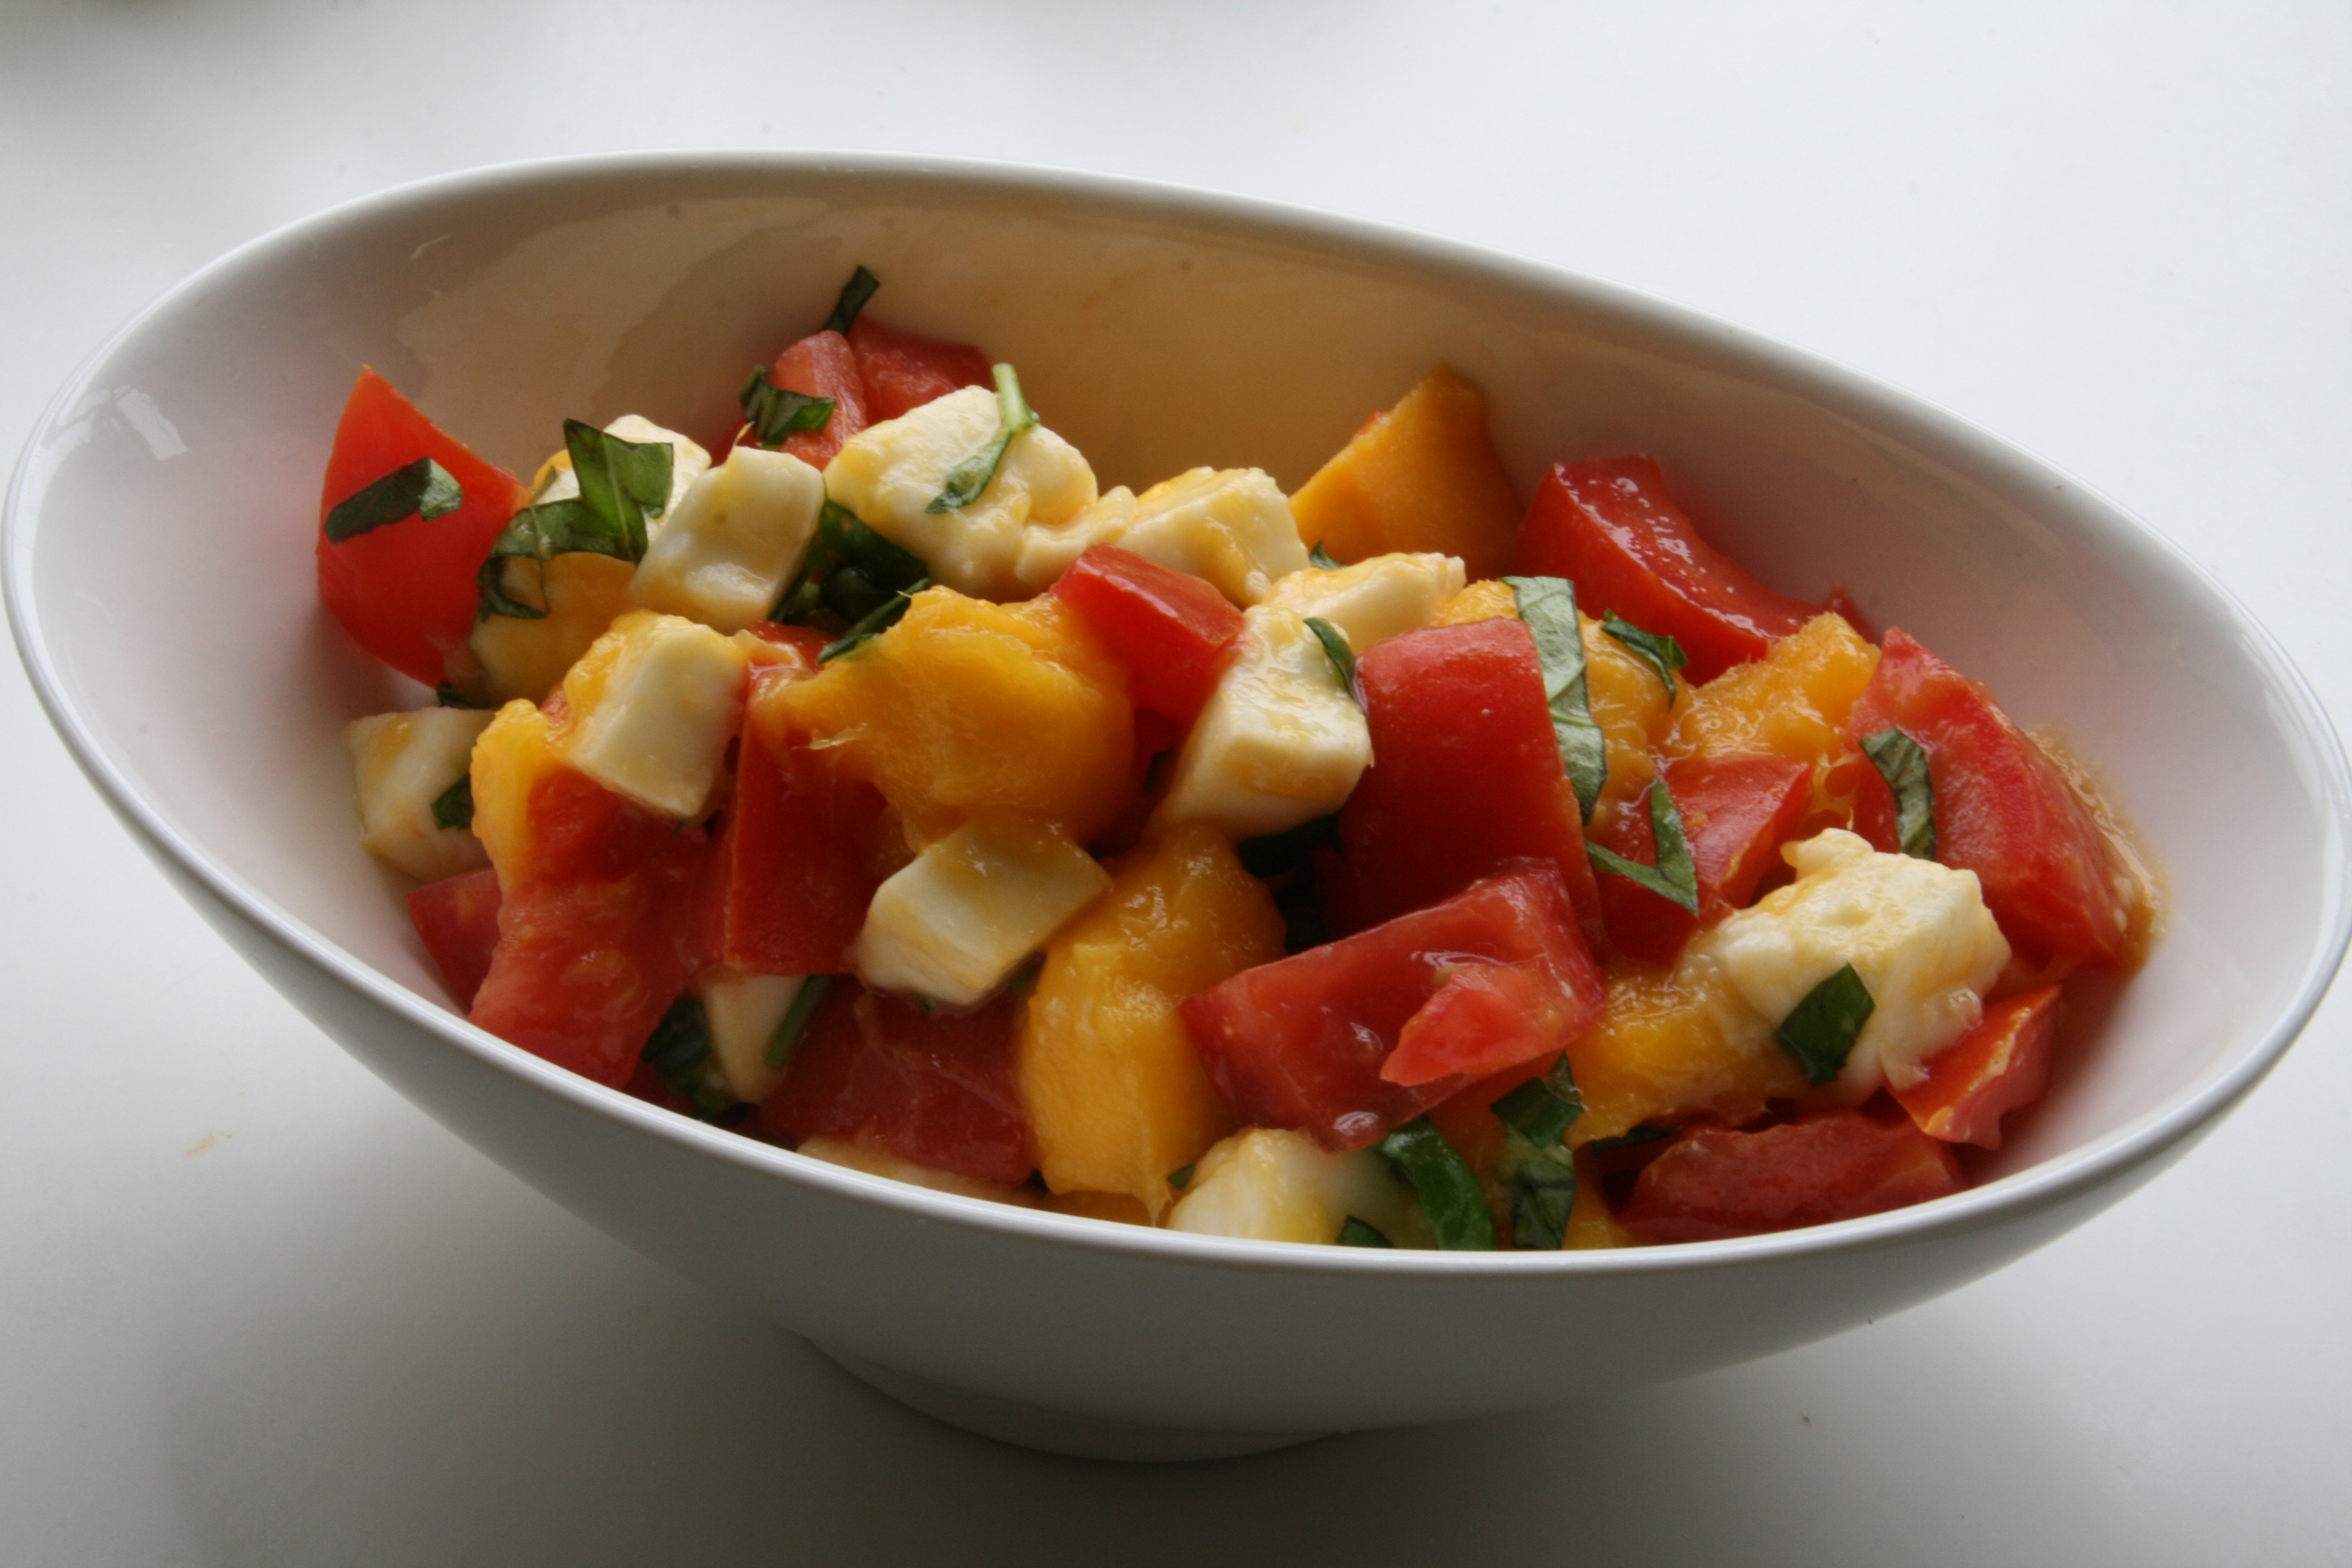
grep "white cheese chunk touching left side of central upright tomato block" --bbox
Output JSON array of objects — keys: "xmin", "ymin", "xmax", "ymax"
[{"xmin": 1157, "ymin": 604, "xmax": 1371, "ymax": 839}]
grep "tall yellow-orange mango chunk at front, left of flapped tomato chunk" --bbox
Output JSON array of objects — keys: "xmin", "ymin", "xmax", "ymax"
[{"xmin": 1019, "ymin": 823, "xmax": 1282, "ymax": 1220}]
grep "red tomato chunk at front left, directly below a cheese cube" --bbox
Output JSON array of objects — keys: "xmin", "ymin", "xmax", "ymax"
[{"xmin": 471, "ymin": 769, "xmax": 713, "ymax": 1086}]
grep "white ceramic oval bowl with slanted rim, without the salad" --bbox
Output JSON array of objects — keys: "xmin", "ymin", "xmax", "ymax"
[{"xmin": 7, "ymin": 153, "xmax": 2347, "ymax": 1457}]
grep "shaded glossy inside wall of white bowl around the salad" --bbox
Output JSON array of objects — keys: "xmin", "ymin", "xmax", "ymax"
[{"xmin": 10, "ymin": 157, "xmax": 2345, "ymax": 1213}]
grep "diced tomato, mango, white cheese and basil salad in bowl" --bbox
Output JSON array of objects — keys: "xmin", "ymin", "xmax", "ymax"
[{"xmin": 318, "ymin": 268, "xmax": 2152, "ymax": 1248}]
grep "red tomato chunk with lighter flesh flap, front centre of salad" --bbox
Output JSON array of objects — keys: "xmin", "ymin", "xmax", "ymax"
[{"xmin": 1178, "ymin": 863, "xmax": 1607, "ymax": 1149}]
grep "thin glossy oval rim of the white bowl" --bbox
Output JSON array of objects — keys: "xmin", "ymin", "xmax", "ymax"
[{"xmin": 18, "ymin": 148, "xmax": 2352, "ymax": 1279}]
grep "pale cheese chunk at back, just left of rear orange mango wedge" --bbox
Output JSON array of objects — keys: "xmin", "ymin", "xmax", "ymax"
[{"xmin": 1019, "ymin": 468, "xmax": 1308, "ymax": 609}]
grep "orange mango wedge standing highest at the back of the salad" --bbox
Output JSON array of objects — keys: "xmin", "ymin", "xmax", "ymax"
[{"xmin": 1292, "ymin": 364, "xmax": 1526, "ymax": 578}]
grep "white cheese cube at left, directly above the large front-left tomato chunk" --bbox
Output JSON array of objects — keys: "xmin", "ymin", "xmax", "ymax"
[{"xmin": 564, "ymin": 609, "xmax": 748, "ymax": 820}]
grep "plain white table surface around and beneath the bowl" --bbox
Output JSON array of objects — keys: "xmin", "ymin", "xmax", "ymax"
[{"xmin": 0, "ymin": 0, "xmax": 2352, "ymax": 1566}]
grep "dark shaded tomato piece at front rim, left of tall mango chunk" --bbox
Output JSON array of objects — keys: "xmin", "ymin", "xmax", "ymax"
[{"xmin": 760, "ymin": 976, "xmax": 1037, "ymax": 1187}]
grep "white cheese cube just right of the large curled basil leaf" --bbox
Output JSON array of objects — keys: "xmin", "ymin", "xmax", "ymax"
[{"xmin": 628, "ymin": 446, "xmax": 826, "ymax": 632}]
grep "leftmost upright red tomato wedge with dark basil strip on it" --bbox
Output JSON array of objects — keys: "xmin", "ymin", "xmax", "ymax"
[{"xmin": 318, "ymin": 369, "xmax": 529, "ymax": 687}]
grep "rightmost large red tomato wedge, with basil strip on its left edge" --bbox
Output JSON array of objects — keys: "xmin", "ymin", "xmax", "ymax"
[{"xmin": 1851, "ymin": 630, "xmax": 2135, "ymax": 964}]
